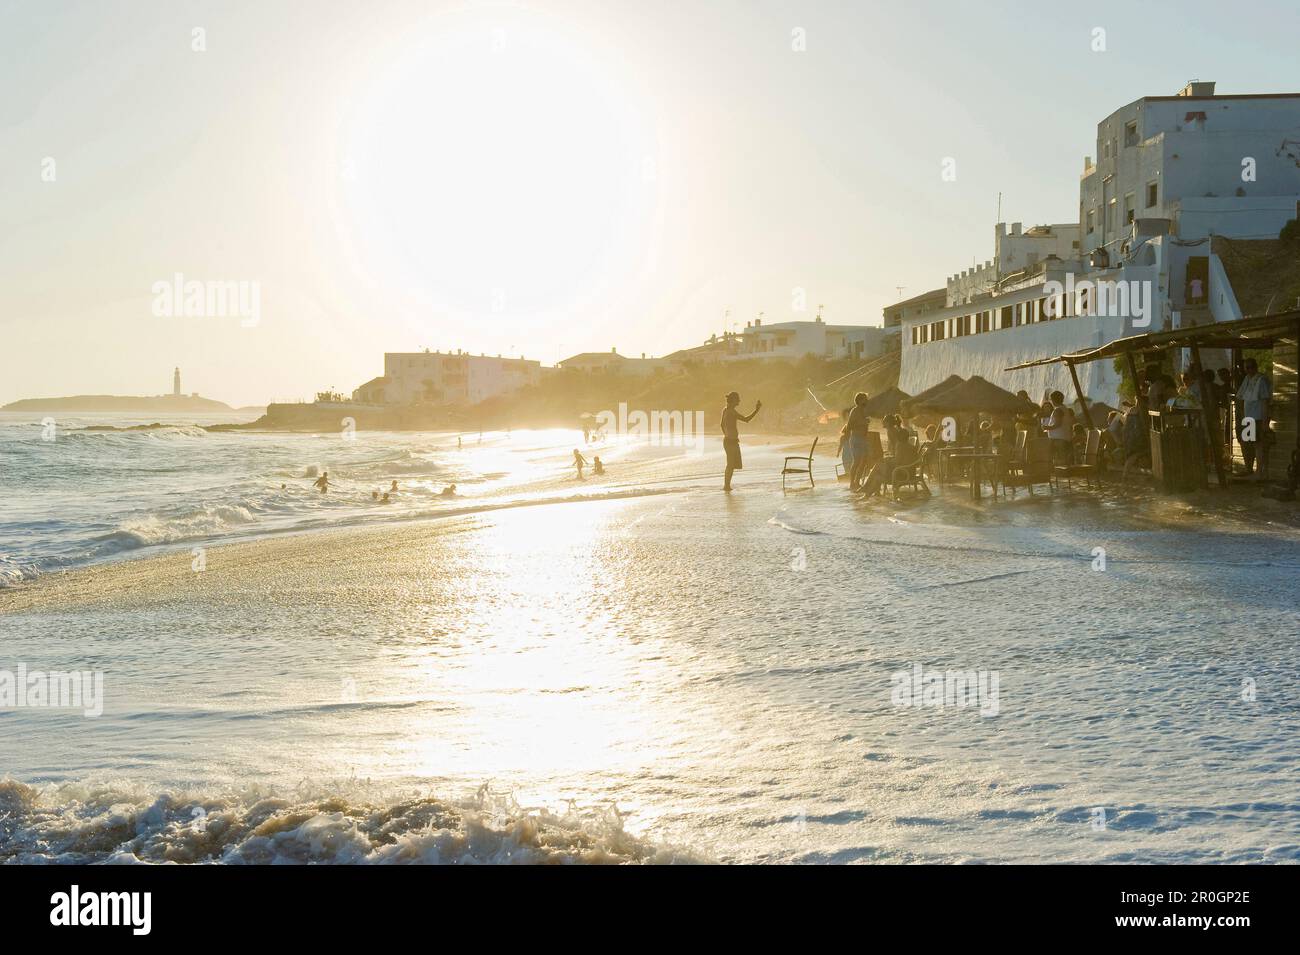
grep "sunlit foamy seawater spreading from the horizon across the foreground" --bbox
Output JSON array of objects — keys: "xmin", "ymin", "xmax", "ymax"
[{"xmin": 0, "ymin": 414, "xmax": 1300, "ymax": 864}]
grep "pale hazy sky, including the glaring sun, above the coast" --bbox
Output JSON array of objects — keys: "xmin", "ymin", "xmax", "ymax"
[{"xmin": 0, "ymin": 0, "xmax": 1300, "ymax": 405}]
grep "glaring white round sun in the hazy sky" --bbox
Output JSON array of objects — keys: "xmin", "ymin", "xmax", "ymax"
[{"xmin": 343, "ymin": 9, "xmax": 658, "ymax": 333}]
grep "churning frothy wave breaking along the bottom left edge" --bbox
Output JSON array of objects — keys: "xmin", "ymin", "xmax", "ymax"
[{"xmin": 0, "ymin": 780, "xmax": 706, "ymax": 865}]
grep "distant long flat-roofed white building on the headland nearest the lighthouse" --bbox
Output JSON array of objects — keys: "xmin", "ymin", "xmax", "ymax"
[{"xmin": 352, "ymin": 350, "xmax": 541, "ymax": 405}]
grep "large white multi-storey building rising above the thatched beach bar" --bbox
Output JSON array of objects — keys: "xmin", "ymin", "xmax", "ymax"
[{"xmin": 898, "ymin": 83, "xmax": 1300, "ymax": 404}]
